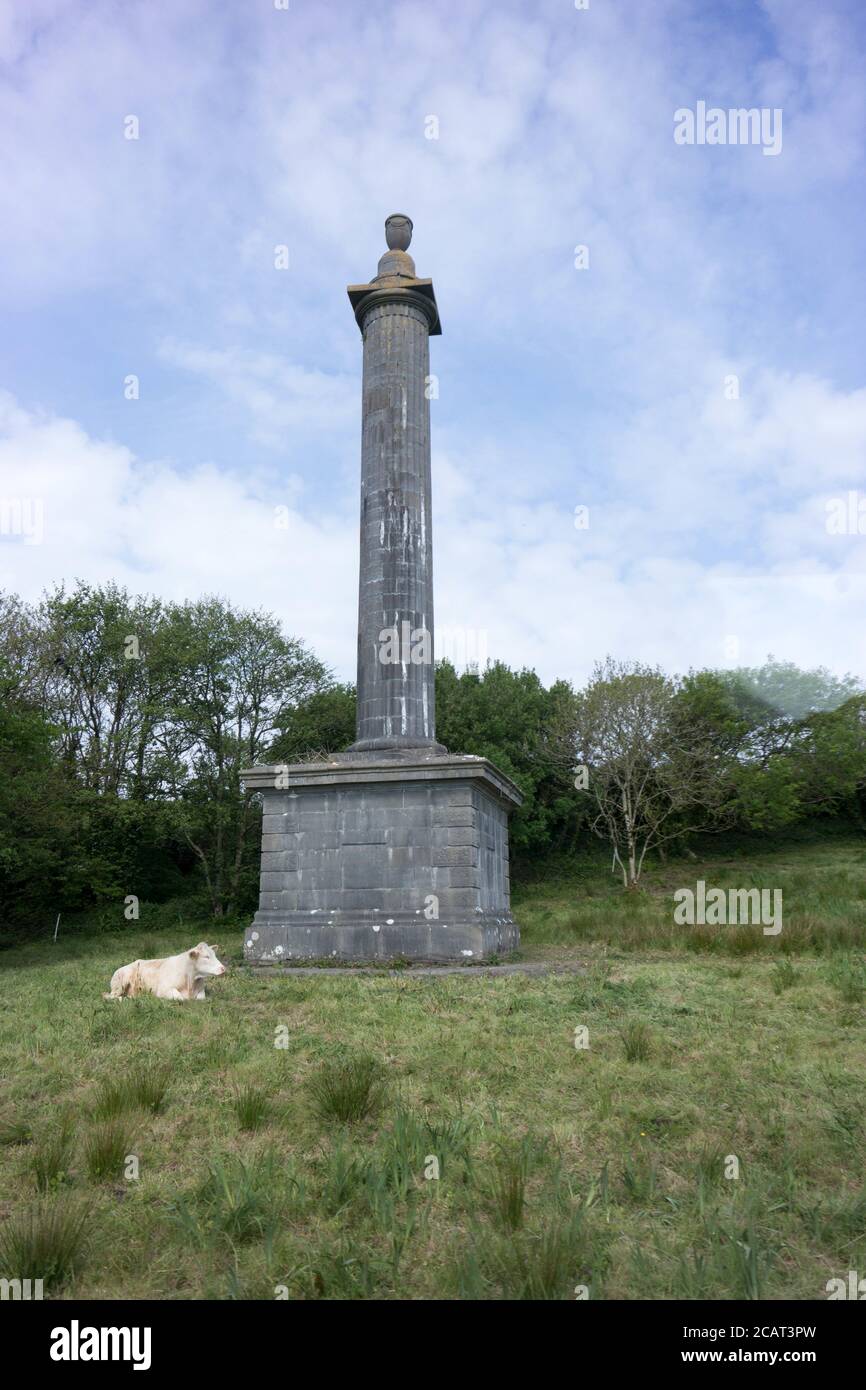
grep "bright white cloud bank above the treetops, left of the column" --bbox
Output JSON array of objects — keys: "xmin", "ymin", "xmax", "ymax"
[{"xmin": 0, "ymin": 398, "xmax": 357, "ymax": 669}]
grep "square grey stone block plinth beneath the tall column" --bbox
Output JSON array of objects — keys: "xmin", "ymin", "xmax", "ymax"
[{"xmin": 243, "ymin": 755, "xmax": 523, "ymax": 965}]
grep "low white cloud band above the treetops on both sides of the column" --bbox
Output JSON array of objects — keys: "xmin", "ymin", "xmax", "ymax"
[{"xmin": 0, "ymin": 382, "xmax": 866, "ymax": 692}]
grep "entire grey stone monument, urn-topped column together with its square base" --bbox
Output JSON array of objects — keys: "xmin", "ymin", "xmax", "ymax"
[{"xmin": 242, "ymin": 215, "xmax": 523, "ymax": 965}]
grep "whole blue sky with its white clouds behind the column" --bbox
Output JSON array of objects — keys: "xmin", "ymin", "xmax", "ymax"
[{"xmin": 0, "ymin": 0, "xmax": 866, "ymax": 681}]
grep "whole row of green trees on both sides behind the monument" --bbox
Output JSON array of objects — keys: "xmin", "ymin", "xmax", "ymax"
[{"xmin": 0, "ymin": 582, "xmax": 866, "ymax": 927}]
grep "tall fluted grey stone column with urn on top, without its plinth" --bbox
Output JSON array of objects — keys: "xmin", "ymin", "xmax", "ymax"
[{"xmin": 349, "ymin": 214, "xmax": 445, "ymax": 753}]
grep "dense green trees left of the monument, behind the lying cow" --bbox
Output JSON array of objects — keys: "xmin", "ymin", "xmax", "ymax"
[{"xmin": 0, "ymin": 584, "xmax": 329, "ymax": 919}]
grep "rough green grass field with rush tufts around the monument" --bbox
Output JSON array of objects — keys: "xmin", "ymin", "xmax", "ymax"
[{"xmin": 0, "ymin": 837, "xmax": 866, "ymax": 1298}]
